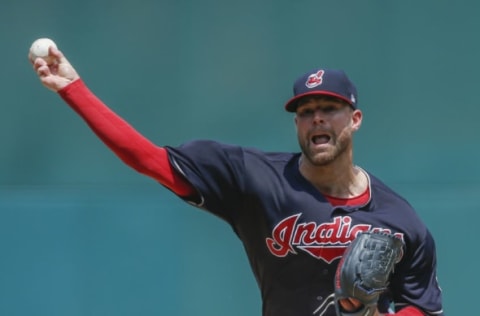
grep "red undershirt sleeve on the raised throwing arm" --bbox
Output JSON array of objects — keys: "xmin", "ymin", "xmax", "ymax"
[{"xmin": 58, "ymin": 79, "xmax": 195, "ymax": 197}]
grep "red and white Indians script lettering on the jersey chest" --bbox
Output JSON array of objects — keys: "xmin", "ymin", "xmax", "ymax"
[{"xmin": 265, "ymin": 213, "xmax": 403, "ymax": 263}]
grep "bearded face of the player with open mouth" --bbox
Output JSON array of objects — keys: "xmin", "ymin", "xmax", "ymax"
[{"xmin": 295, "ymin": 97, "xmax": 362, "ymax": 166}]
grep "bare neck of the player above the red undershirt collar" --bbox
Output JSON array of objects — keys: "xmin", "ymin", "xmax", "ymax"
[{"xmin": 299, "ymin": 155, "xmax": 368, "ymax": 198}]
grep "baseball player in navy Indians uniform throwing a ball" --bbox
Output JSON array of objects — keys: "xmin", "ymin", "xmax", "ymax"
[{"xmin": 31, "ymin": 47, "xmax": 444, "ymax": 316}]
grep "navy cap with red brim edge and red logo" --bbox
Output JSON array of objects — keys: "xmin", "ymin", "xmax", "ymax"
[{"xmin": 285, "ymin": 69, "xmax": 357, "ymax": 112}]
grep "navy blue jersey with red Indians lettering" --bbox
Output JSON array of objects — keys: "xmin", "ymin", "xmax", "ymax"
[{"xmin": 167, "ymin": 141, "xmax": 443, "ymax": 316}]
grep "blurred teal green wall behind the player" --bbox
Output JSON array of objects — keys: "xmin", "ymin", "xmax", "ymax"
[{"xmin": 0, "ymin": 0, "xmax": 480, "ymax": 316}]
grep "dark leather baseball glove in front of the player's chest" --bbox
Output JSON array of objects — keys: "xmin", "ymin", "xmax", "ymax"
[{"xmin": 334, "ymin": 232, "xmax": 403, "ymax": 316}]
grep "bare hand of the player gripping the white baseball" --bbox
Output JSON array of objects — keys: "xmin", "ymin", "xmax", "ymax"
[{"xmin": 28, "ymin": 38, "xmax": 80, "ymax": 92}]
